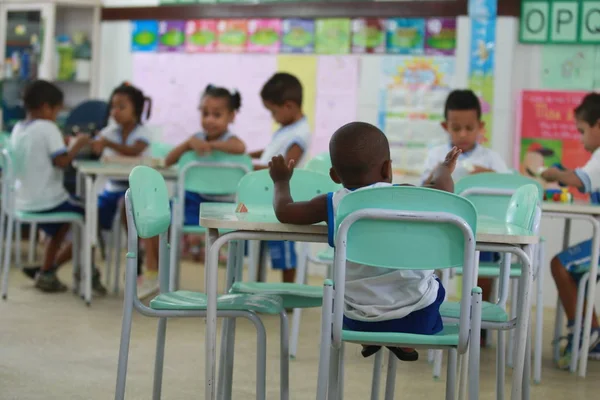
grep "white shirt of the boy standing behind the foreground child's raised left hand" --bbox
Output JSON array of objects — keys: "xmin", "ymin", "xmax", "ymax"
[{"xmin": 260, "ymin": 117, "xmax": 310, "ymax": 167}]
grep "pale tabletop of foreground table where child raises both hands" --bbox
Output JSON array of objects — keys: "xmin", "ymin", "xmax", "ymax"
[{"xmin": 200, "ymin": 203, "xmax": 539, "ymax": 245}]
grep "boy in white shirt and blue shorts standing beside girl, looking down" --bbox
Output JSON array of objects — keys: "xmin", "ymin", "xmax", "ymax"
[{"xmin": 250, "ymin": 72, "xmax": 310, "ymax": 283}]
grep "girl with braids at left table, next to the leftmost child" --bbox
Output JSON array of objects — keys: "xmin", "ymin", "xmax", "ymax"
[{"xmin": 92, "ymin": 83, "xmax": 158, "ymax": 294}]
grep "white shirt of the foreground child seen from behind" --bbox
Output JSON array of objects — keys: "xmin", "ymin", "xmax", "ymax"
[{"xmin": 327, "ymin": 183, "xmax": 440, "ymax": 322}]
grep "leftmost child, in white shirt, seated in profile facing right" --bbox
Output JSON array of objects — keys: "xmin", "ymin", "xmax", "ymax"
[{"xmin": 11, "ymin": 81, "xmax": 106, "ymax": 294}]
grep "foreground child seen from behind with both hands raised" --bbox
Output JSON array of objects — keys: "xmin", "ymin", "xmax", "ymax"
[{"xmin": 269, "ymin": 122, "xmax": 460, "ymax": 361}]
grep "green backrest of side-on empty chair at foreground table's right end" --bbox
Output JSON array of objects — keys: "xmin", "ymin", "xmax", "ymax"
[{"xmin": 506, "ymin": 185, "xmax": 542, "ymax": 233}]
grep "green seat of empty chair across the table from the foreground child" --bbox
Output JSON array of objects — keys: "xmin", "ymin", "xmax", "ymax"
[{"xmin": 230, "ymin": 282, "xmax": 323, "ymax": 308}]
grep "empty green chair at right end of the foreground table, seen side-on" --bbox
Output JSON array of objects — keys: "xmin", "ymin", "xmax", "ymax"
[{"xmin": 436, "ymin": 184, "xmax": 543, "ymax": 399}]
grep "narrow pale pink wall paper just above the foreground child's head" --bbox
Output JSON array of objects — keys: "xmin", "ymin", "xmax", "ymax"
[{"xmin": 310, "ymin": 56, "xmax": 359, "ymax": 155}]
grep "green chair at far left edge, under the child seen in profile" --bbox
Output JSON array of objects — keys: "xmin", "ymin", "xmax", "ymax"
[{"xmin": 0, "ymin": 147, "xmax": 92, "ymax": 305}]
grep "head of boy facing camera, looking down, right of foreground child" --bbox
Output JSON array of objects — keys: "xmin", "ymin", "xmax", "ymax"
[{"xmin": 442, "ymin": 90, "xmax": 484, "ymax": 153}]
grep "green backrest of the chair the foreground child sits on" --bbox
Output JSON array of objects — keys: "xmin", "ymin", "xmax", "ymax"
[{"xmin": 336, "ymin": 186, "xmax": 477, "ymax": 270}]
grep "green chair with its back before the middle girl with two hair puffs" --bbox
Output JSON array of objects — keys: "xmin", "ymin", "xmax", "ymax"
[{"xmin": 170, "ymin": 151, "xmax": 252, "ymax": 290}]
